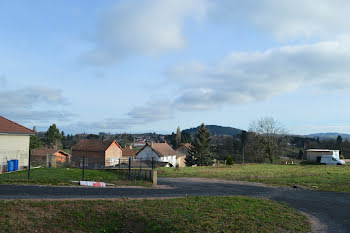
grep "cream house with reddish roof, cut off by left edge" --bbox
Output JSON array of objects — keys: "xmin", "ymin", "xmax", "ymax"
[{"xmin": 0, "ymin": 116, "xmax": 35, "ymax": 172}]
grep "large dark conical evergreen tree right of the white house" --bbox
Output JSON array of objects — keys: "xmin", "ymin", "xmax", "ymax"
[{"xmin": 186, "ymin": 123, "xmax": 214, "ymax": 166}]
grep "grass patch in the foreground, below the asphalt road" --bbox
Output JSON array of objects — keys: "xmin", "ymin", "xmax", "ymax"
[{"xmin": 0, "ymin": 197, "xmax": 310, "ymax": 232}]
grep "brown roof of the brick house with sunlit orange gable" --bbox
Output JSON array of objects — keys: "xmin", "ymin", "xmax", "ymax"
[{"xmin": 72, "ymin": 139, "xmax": 123, "ymax": 151}]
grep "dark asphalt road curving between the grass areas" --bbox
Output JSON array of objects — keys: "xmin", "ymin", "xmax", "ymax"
[{"xmin": 0, "ymin": 178, "xmax": 350, "ymax": 232}]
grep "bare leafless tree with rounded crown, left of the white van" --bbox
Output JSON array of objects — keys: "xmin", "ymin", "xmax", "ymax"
[{"xmin": 249, "ymin": 117, "xmax": 287, "ymax": 163}]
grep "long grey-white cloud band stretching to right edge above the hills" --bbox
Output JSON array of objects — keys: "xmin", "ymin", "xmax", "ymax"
[{"xmin": 167, "ymin": 39, "xmax": 350, "ymax": 110}]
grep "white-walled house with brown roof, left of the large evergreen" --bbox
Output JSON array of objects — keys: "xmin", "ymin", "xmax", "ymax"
[{"xmin": 136, "ymin": 142, "xmax": 176, "ymax": 167}]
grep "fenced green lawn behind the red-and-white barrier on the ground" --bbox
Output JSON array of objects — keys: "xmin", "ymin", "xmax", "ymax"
[{"xmin": 0, "ymin": 168, "xmax": 151, "ymax": 186}]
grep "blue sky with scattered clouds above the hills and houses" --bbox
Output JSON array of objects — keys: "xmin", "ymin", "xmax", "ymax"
[{"xmin": 0, "ymin": 0, "xmax": 350, "ymax": 134}]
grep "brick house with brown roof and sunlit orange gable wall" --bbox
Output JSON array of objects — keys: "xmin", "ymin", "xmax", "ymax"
[{"xmin": 72, "ymin": 139, "xmax": 123, "ymax": 168}]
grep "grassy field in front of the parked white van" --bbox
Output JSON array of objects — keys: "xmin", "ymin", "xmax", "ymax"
[{"xmin": 157, "ymin": 164, "xmax": 350, "ymax": 192}]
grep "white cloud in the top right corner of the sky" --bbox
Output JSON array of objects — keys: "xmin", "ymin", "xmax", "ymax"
[{"xmin": 210, "ymin": 0, "xmax": 350, "ymax": 41}]
